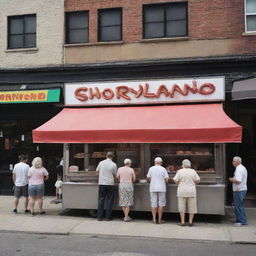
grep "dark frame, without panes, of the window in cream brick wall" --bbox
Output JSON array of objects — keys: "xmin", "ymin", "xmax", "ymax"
[{"xmin": 7, "ymin": 14, "xmax": 37, "ymax": 50}]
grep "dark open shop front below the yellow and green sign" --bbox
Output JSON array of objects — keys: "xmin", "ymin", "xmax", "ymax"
[{"xmin": 0, "ymin": 104, "xmax": 63, "ymax": 195}]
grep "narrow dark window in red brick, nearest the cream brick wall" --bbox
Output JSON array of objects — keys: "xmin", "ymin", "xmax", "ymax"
[{"xmin": 66, "ymin": 11, "xmax": 89, "ymax": 44}]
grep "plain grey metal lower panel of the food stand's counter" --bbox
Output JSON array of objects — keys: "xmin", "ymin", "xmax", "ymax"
[{"xmin": 63, "ymin": 182, "xmax": 225, "ymax": 215}]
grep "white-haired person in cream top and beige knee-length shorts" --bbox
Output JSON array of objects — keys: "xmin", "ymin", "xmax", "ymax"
[{"xmin": 173, "ymin": 159, "xmax": 200, "ymax": 227}]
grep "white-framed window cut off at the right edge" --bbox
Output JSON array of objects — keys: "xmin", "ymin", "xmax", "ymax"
[{"xmin": 245, "ymin": 0, "xmax": 256, "ymax": 32}]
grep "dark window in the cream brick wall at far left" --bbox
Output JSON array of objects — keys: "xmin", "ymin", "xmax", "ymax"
[{"xmin": 8, "ymin": 14, "xmax": 36, "ymax": 49}]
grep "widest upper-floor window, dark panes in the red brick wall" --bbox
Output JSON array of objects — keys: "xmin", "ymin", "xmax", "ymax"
[{"xmin": 143, "ymin": 3, "xmax": 188, "ymax": 39}]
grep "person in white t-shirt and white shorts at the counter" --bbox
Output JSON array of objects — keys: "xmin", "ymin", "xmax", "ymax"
[{"xmin": 147, "ymin": 157, "xmax": 169, "ymax": 224}]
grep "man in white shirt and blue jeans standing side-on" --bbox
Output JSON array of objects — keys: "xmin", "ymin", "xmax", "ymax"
[{"xmin": 229, "ymin": 156, "xmax": 247, "ymax": 227}]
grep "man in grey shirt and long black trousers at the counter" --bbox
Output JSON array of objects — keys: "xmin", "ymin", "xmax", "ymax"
[{"xmin": 96, "ymin": 152, "xmax": 117, "ymax": 221}]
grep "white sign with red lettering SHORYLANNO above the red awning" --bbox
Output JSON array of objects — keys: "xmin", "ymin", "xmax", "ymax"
[{"xmin": 65, "ymin": 77, "xmax": 225, "ymax": 106}]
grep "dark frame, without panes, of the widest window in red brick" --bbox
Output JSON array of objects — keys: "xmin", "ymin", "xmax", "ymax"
[{"xmin": 142, "ymin": 2, "xmax": 188, "ymax": 39}]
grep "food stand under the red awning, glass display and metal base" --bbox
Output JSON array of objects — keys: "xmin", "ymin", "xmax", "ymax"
[{"xmin": 63, "ymin": 143, "xmax": 225, "ymax": 215}]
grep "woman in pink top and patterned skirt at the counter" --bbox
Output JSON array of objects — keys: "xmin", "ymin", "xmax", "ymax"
[{"xmin": 116, "ymin": 158, "xmax": 136, "ymax": 221}]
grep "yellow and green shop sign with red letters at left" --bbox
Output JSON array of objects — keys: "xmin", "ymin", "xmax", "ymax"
[{"xmin": 0, "ymin": 89, "xmax": 60, "ymax": 103}]
